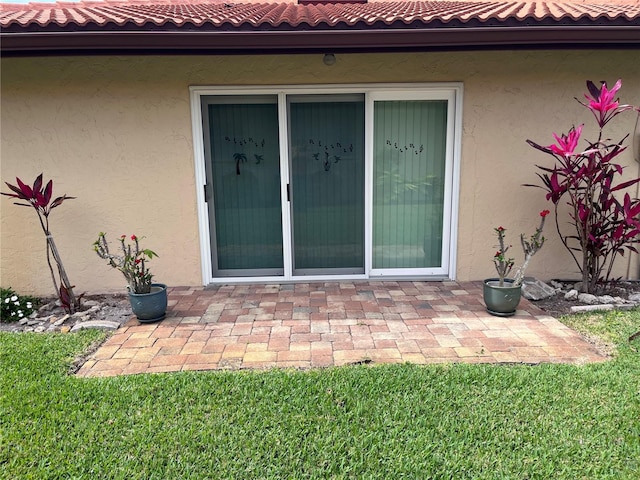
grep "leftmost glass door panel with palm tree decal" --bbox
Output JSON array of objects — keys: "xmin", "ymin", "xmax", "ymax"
[{"xmin": 208, "ymin": 97, "xmax": 283, "ymax": 275}]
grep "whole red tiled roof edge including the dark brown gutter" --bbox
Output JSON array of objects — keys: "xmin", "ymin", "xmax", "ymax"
[{"xmin": 0, "ymin": 0, "xmax": 640, "ymax": 54}]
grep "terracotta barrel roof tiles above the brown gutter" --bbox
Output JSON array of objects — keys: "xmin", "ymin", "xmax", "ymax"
[{"xmin": 0, "ymin": 0, "xmax": 640, "ymax": 29}]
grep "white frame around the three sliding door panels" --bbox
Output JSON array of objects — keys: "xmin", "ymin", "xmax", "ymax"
[{"xmin": 189, "ymin": 82, "xmax": 463, "ymax": 285}]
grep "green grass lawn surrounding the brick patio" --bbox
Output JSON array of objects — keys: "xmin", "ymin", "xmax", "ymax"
[{"xmin": 0, "ymin": 311, "xmax": 640, "ymax": 479}]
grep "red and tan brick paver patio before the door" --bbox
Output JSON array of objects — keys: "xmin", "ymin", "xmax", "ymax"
[{"xmin": 78, "ymin": 282, "xmax": 605, "ymax": 377}]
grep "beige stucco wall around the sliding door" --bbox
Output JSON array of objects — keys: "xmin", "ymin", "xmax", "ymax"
[{"xmin": 0, "ymin": 51, "xmax": 640, "ymax": 294}]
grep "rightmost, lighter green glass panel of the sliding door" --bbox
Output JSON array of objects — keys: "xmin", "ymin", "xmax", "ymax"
[{"xmin": 373, "ymin": 100, "xmax": 447, "ymax": 269}]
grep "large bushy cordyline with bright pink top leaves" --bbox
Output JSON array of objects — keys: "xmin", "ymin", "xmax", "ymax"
[{"xmin": 527, "ymin": 80, "xmax": 640, "ymax": 293}]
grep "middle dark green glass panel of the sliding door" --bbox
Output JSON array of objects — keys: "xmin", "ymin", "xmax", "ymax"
[{"xmin": 289, "ymin": 95, "xmax": 364, "ymax": 274}]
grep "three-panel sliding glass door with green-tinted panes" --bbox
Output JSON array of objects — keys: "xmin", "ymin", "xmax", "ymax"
[{"xmin": 199, "ymin": 88, "xmax": 460, "ymax": 279}]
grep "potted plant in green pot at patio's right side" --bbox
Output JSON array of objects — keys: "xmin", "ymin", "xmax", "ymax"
[{"xmin": 483, "ymin": 210, "xmax": 549, "ymax": 317}]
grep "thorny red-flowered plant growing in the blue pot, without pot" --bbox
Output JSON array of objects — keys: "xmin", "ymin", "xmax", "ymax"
[{"xmin": 93, "ymin": 232, "xmax": 158, "ymax": 293}]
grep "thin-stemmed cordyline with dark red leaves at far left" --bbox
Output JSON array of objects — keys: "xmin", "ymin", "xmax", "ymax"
[{"xmin": 1, "ymin": 174, "xmax": 80, "ymax": 313}]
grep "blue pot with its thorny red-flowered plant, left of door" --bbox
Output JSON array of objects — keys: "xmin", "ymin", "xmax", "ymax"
[{"xmin": 93, "ymin": 232, "xmax": 167, "ymax": 323}]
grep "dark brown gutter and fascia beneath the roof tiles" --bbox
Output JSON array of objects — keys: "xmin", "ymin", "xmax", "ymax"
[{"xmin": 1, "ymin": 26, "xmax": 640, "ymax": 56}]
